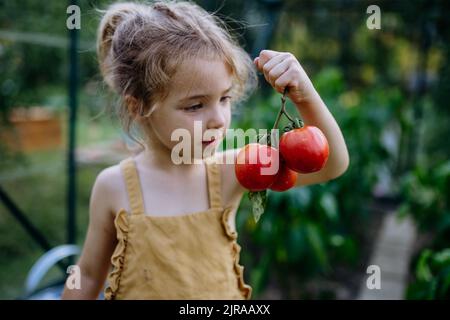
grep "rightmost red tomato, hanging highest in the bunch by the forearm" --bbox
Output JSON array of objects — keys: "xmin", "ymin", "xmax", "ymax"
[{"xmin": 280, "ymin": 126, "xmax": 329, "ymax": 173}]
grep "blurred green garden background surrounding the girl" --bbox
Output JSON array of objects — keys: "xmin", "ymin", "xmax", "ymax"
[{"xmin": 0, "ymin": 0, "xmax": 450, "ymax": 299}]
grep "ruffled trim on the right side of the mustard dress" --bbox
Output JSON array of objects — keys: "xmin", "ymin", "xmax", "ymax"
[{"xmin": 222, "ymin": 207, "xmax": 252, "ymax": 300}]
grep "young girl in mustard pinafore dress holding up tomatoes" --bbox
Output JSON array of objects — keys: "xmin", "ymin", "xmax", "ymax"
[{"xmin": 63, "ymin": 1, "xmax": 349, "ymax": 299}]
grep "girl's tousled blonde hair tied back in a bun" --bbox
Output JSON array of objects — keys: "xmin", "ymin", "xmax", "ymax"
[{"xmin": 97, "ymin": 0, "xmax": 257, "ymax": 142}]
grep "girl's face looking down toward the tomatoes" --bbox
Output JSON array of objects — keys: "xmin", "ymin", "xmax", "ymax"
[{"xmin": 148, "ymin": 59, "xmax": 236, "ymax": 158}]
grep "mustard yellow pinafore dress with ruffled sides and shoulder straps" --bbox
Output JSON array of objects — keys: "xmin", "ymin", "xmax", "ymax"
[{"xmin": 105, "ymin": 157, "xmax": 252, "ymax": 300}]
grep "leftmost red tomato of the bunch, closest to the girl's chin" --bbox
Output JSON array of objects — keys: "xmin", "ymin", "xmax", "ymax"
[{"xmin": 234, "ymin": 143, "xmax": 280, "ymax": 191}]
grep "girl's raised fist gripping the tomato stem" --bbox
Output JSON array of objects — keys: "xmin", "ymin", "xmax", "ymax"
[{"xmin": 253, "ymin": 50, "xmax": 315, "ymax": 104}]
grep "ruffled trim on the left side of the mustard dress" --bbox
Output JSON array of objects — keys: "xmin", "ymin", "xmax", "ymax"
[{"xmin": 105, "ymin": 210, "xmax": 129, "ymax": 300}]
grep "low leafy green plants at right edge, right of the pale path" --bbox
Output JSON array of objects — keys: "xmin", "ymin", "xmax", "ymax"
[{"xmin": 399, "ymin": 161, "xmax": 450, "ymax": 299}]
